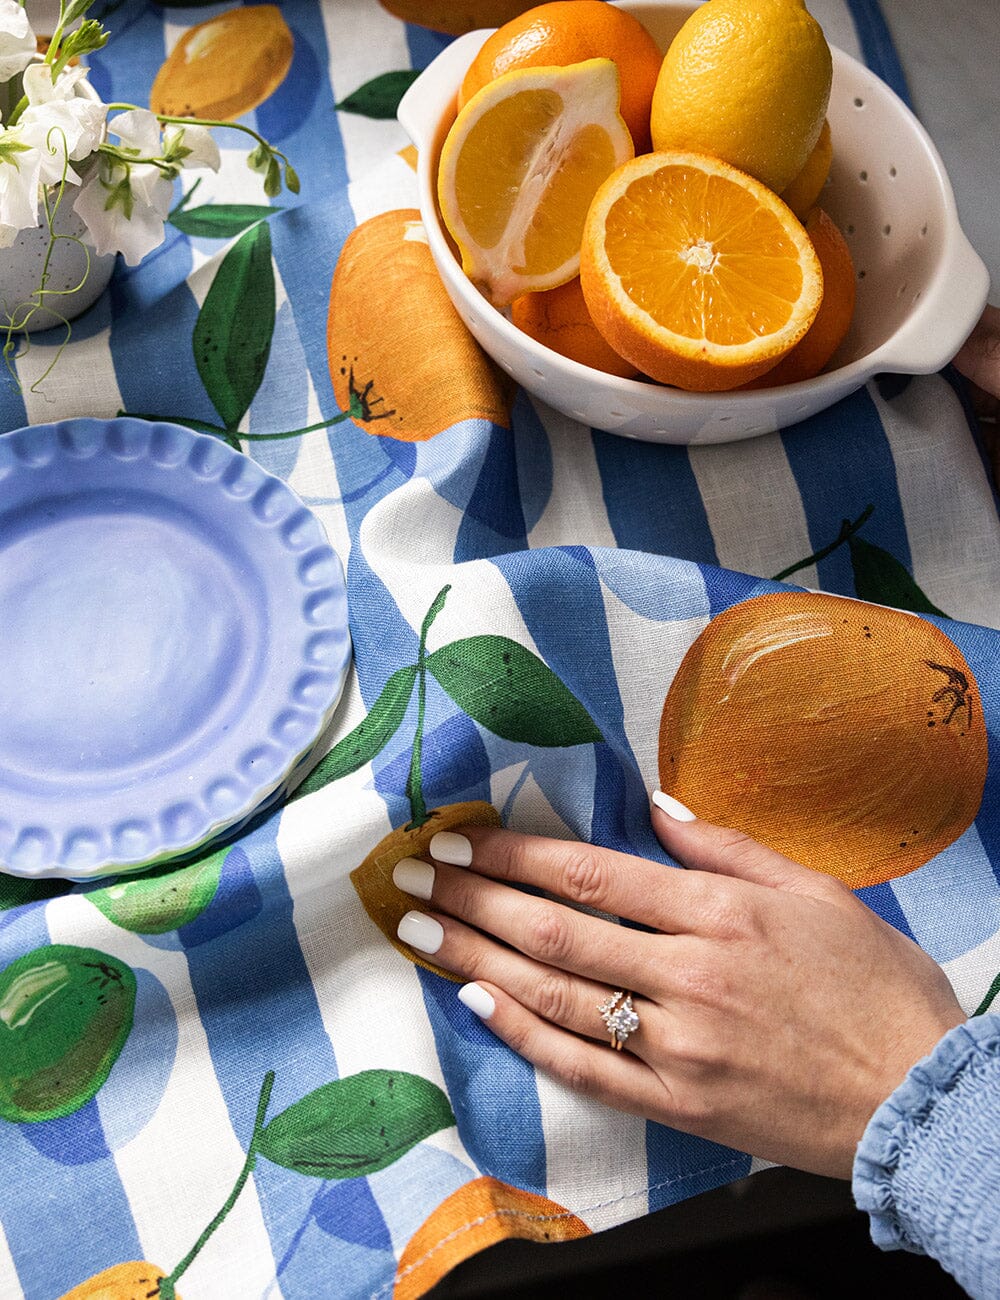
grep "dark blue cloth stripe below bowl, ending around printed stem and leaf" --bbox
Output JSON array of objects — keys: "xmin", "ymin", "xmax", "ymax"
[{"xmin": 782, "ymin": 389, "xmax": 913, "ymax": 595}]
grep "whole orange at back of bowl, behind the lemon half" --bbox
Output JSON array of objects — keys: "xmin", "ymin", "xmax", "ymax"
[{"xmin": 458, "ymin": 0, "xmax": 663, "ymax": 153}]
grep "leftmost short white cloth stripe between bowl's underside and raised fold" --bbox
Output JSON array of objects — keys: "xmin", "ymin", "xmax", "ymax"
[{"xmin": 528, "ymin": 399, "xmax": 618, "ymax": 549}]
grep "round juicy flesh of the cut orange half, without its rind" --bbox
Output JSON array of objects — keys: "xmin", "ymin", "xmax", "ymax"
[{"xmin": 605, "ymin": 166, "xmax": 802, "ymax": 346}]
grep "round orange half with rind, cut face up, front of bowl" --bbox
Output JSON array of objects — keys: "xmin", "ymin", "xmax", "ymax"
[{"xmin": 580, "ymin": 152, "xmax": 823, "ymax": 391}]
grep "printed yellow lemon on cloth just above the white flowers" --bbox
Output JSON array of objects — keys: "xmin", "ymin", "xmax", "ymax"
[{"xmin": 150, "ymin": 4, "xmax": 294, "ymax": 121}]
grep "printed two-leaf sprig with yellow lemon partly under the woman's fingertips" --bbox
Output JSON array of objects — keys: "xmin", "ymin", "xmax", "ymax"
[{"xmin": 293, "ymin": 586, "xmax": 602, "ymax": 980}]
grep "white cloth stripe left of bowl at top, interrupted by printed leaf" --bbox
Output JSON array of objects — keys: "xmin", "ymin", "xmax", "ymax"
[{"xmin": 320, "ymin": 0, "xmax": 410, "ymax": 188}]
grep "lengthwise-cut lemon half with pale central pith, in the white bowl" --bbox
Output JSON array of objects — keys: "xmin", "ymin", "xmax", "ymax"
[{"xmin": 438, "ymin": 59, "xmax": 632, "ymax": 307}]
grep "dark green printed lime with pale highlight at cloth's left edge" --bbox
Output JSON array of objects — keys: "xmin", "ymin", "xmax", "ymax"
[{"xmin": 0, "ymin": 944, "xmax": 135, "ymax": 1122}]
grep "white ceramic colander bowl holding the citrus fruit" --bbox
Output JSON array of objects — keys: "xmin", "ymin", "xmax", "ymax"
[{"xmin": 399, "ymin": 4, "xmax": 990, "ymax": 443}]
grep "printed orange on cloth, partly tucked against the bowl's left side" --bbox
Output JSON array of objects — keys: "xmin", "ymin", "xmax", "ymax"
[{"xmin": 326, "ymin": 208, "xmax": 512, "ymax": 442}]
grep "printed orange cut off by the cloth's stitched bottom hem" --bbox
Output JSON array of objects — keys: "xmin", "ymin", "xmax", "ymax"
[{"xmin": 393, "ymin": 1178, "xmax": 590, "ymax": 1300}]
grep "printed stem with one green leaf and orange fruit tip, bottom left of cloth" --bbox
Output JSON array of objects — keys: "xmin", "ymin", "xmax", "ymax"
[{"xmin": 61, "ymin": 1070, "xmax": 455, "ymax": 1300}]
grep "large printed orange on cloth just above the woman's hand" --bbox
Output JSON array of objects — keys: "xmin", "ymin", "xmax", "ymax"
[{"xmin": 659, "ymin": 592, "xmax": 987, "ymax": 888}]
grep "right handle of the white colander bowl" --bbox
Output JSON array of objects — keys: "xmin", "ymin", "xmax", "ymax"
[{"xmin": 873, "ymin": 228, "xmax": 990, "ymax": 374}]
